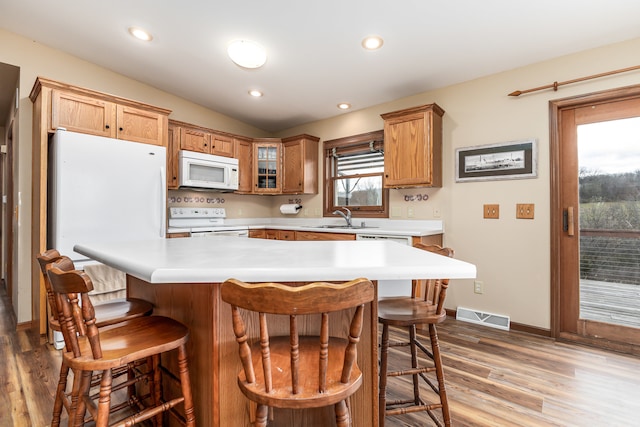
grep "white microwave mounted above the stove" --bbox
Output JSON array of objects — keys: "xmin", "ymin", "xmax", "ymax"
[{"xmin": 178, "ymin": 150, "xmax": 238, "ymax": 191}]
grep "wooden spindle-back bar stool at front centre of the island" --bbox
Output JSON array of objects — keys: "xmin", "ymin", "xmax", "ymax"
[{"xmin": 221, "ymin": 279, "xmax": 374, "ymax": 427}]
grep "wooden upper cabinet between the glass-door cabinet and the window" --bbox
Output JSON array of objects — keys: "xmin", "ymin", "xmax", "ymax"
[{"xmin": 282, "ymin": 134, "xmax": 320, "ymax": 194}]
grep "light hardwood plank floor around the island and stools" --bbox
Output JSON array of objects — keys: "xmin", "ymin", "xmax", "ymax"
[{"xmin": 0, "ymin": 285, "xmax": 640, "ymax": 427}]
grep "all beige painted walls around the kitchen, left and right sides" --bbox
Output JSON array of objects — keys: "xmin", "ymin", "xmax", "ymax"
[{"xmin": 0, "ymin": 25, "xmax": 640, "ymax": 328}]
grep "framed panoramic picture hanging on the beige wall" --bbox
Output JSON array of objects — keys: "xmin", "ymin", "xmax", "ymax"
[{"xmin": 456, "ymin": 138, "xmax": 538, "ymax": 182}]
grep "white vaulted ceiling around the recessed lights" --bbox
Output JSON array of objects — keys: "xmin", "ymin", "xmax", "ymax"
[{"xmin": 0, "ymin": 0, "xmax": 640, "ymax": 131}]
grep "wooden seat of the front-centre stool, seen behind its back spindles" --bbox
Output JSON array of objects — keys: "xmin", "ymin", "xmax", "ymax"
[{"xmin": 238, "ymin": 336, "xmax": 362, "ymax": 409}]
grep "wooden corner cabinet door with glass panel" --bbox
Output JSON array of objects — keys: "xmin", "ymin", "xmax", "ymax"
[{"xmin": 253, "ymin": 138, "xmax": 282, "ymax": 194}]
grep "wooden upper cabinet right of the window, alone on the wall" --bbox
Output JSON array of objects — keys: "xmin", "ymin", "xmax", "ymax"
[{"xmin": 381, "ymin": 104, "xmax": 444, "ymax": 188}]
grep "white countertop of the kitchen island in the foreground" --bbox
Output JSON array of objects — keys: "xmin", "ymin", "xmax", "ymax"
[{"xmin": 74, "ymin": 237, "xmax": 476, "ymax": 283}]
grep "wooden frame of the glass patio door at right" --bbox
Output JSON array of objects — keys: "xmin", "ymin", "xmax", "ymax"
[{"xmin": 549, "ymin": 85, "xmax": 640, "ymax": 354}]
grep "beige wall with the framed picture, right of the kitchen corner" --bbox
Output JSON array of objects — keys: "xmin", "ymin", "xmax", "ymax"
[{"xmin": 283, "ymin": 39, "xmax": 640, "ymax": 328}]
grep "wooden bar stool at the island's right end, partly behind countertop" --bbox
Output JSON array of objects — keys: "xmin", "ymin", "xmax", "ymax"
[{"xmin": 378, "ymin": 244, "xmax": 453, "ymax": 427}]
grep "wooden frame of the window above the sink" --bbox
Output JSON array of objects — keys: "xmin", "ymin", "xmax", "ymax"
[{"xmin": 322, "ymin": 129, "xmax": 389, "ymax": 218}]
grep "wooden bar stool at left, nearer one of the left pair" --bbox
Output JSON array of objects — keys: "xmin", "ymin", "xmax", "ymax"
[{"xmin": 47, "ymin": 258, "xmax": 195, "ymax": 427}]
